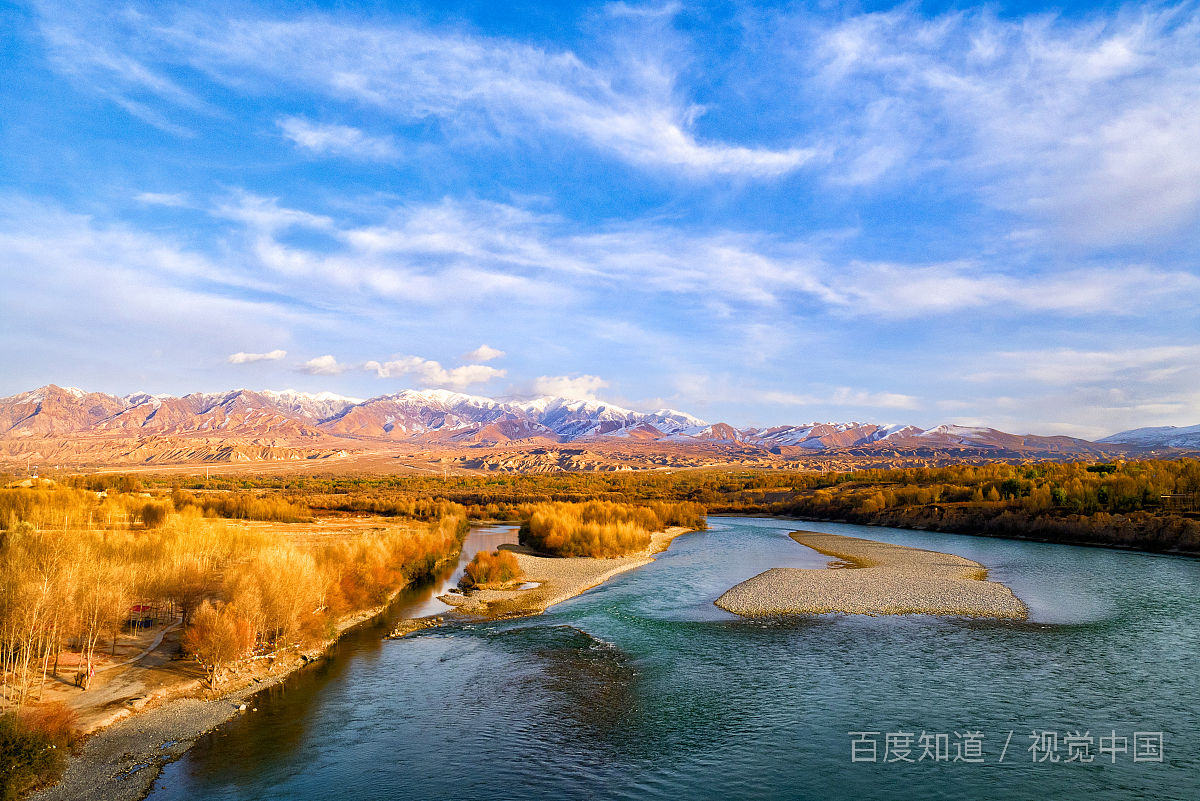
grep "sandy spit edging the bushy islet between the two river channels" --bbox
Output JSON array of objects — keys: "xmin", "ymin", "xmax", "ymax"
[{"xmin": 438, "ymin": 526, "xmax": 692, "ymax": 618}]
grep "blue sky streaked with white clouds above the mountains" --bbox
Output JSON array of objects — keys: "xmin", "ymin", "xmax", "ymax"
[{"xmin": 0, "ymin": 0, "xmax": 1200, "ymax": 438}]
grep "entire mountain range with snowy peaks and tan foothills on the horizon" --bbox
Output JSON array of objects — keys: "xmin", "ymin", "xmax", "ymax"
[{"xmin": 0, "ymin": 385, "xmax": 1200, "ymax": 470}]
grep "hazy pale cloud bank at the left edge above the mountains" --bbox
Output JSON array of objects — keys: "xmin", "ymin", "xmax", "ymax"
[{"xmin": 0, "ymin": 195, "xmax": 304, "ymax": 391}]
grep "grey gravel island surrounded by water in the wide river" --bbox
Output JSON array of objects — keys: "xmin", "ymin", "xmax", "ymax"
[{"xmin": 715, "ymin": 531, "xmax": 1028, "ymax": 620}]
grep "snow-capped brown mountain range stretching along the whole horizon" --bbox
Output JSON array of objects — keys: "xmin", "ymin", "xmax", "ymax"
[{"xmin": 0, "ymin": 385, "xmax": 1171, "ymax": 458}]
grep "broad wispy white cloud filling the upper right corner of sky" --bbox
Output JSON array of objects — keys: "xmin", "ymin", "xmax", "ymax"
[{"xmin": 784, "ymin": 2, "xmax": 1200, "ymax": 245}]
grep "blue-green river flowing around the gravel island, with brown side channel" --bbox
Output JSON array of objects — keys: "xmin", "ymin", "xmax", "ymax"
[{"xmin": 142, "ymin": 517, "xmax": 1200, "ymax": 801}]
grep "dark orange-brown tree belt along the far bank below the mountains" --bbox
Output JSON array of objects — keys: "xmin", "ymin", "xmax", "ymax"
[{"xmin": 63, "ymin": 459, "xmax": 1200, "ymax": 553}]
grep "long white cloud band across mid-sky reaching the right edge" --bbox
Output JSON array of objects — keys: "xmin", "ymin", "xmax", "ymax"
[{"xmin": 208, "ymin": 193, "xmax": 1200, "ymax": 318}]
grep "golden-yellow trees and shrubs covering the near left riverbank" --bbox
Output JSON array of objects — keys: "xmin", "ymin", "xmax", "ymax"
[{"xmin": 0, "ymin": 484, "xmax": 467, "ymax": 799}]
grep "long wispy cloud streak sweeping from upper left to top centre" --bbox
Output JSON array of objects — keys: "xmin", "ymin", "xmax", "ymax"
[{"xmin": 35, "ymin": 3, "xmax": 824, "ymax": 179}]
